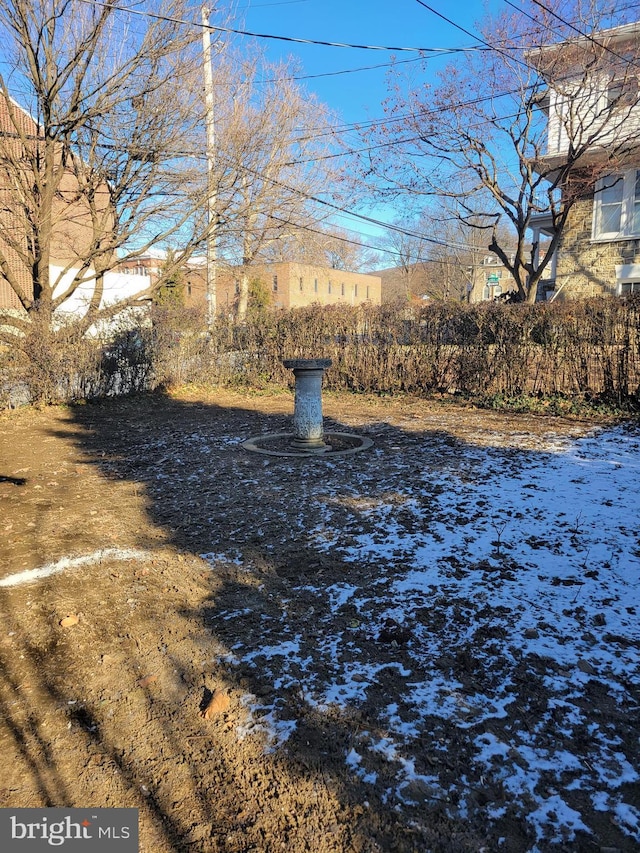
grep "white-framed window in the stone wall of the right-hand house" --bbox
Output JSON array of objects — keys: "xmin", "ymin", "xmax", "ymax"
[{"xmin": 593, "ymin": 169, "xmax": 640, "ymax": 240}]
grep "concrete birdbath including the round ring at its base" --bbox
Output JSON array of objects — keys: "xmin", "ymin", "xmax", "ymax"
[{"xmin": 242, "ymin": 358, "xmax": 373, "ymax": 457}]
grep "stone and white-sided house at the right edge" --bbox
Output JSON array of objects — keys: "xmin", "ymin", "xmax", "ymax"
[{"xmin": 529, "ymin": 23, "xmax": 640, "ymax": 298}]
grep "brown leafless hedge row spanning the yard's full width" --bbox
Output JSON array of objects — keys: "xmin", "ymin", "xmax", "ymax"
[{"xmin": 0, "ymin": 297, "xmax": 640, "ymax": 404}]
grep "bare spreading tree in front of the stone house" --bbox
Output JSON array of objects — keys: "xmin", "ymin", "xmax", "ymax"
[{"xmin": 367, "ymin": 0, "xmax": 638, "ymax": 301}]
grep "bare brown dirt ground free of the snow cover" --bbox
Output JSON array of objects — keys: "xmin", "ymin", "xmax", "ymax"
[{"xmin": 0, "ymin": 391, "xmax": 639, "ymax": 853}]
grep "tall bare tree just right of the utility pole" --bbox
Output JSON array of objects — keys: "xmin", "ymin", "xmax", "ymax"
[{"xmin": 212, "ymin": 56, "xmax": 345, "ymax": 319}]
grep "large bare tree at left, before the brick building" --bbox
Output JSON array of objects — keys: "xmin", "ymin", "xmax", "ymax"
[{"xmin": 0, "ymin": 0, "xmax": 212, "ymax": 346}]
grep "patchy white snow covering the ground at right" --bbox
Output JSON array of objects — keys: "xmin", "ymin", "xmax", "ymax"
[{"xmin": 204, "ymin": 427, "xmax": 640, "ymax": 851}]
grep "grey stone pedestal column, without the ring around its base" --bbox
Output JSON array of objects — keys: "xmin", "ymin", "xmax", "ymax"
[{"xmin": 282, "ymin": 358, "xmax": 331, "ymax": 453}]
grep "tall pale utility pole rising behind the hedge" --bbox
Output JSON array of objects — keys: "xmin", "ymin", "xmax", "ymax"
[{"xmin": 202, "ymin": 6, "xmax": 218, "ymax": 329}]
